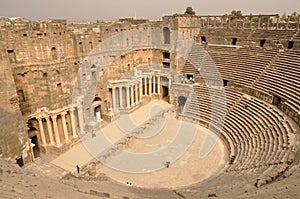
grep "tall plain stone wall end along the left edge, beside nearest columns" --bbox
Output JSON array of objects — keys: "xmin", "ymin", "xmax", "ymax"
[{"xmin": 0, "ymin": 26, "xmax": 30, "ymax": 162}]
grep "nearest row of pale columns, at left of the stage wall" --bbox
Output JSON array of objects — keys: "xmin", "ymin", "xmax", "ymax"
[{"xmin": 37, "ymin": 111, "xmax": 77, "ymax": 146}]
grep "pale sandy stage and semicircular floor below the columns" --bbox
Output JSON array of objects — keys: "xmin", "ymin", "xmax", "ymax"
[{"xmin": 52, "ymin": 101, "xmax": 226, "ymax": 188}]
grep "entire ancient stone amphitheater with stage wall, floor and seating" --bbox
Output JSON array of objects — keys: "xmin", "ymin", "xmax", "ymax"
[{"xmin": 0, "ymin": 14, "xmax": 300, "ymax": 199}]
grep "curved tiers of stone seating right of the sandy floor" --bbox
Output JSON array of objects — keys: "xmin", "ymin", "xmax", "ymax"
[{"xmin": 182, "ymin": 45, "xmax": 300, "ymax": 186}]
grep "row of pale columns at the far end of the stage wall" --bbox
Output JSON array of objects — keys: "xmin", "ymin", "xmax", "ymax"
[{"xmin": 112, "ymin": 76, "xmax": 161, "ymax": 109}]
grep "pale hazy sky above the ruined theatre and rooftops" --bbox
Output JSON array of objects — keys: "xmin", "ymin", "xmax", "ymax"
[{"xmin": 0, "ymin": 0, "xmax": 300, "ymax": 21}]
